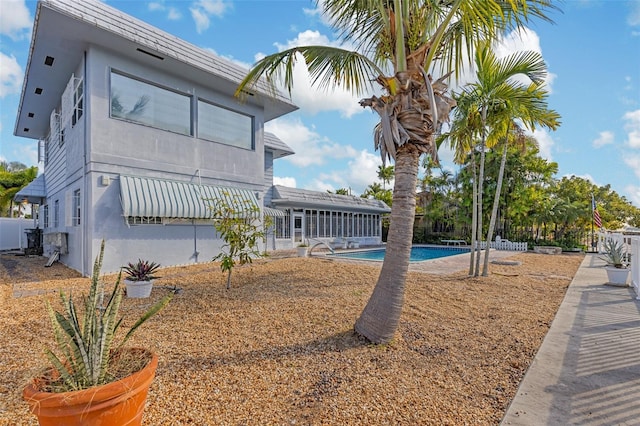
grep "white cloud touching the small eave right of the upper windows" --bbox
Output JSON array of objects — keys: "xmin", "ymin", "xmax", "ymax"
[{"xmin": 265, "ymin": 118, "xmax": 357, "ymax": 167}]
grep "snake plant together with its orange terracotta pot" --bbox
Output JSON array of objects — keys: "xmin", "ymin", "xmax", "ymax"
[{"xmin": 22, "ymin": 241, "xmax": 173, "ymax": 426}]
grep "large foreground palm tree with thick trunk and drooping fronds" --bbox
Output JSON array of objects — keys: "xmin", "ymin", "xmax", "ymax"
[{"xmin": 236, "ymin": 0, "xmax": 554, "ymax": 343}]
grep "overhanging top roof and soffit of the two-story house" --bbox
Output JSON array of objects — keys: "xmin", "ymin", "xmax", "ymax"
[{"xmin": 14, "ymin": 0, "xmax": 298, "ymax": 139}]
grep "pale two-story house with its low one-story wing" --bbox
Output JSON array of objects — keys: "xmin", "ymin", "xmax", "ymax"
[{"xmin": 14, "ymin": 0, "xmax": 389, "ymax": 275}]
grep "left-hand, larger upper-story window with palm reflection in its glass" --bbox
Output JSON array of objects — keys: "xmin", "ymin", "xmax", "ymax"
[{"xmin": 110, "ymin": 71, "xmax": 193, "ymax": 135}]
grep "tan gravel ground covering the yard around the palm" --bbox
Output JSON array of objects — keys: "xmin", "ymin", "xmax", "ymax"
[{"xmin": 0, "ymin": 253, "xmax": 583, "ymax": 425}]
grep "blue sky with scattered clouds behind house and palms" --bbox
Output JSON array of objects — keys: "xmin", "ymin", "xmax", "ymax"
[{"xmin": 0, "ymin": 0, "xmax": 640, "ymax": 206}]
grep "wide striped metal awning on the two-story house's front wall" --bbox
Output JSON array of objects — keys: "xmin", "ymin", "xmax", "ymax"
[{"xmin": 120, "ymin": 175, "xmax": 259, "ymax": 219}]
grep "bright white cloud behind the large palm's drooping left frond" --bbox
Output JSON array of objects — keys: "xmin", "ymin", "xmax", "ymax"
[{"xmin": 256, "ymin": 30, "xmax": 364, "ymax": 118}]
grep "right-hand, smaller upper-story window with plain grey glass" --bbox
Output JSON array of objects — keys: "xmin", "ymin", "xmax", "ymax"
[{"xmin": 198, "ymin": 100, "xmax": 254, "ymax": 149}]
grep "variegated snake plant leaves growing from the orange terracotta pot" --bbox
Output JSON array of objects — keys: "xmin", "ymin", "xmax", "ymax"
[{"xmin": 45, "ymin": 240, "xmax": 174, "ymax": 392}]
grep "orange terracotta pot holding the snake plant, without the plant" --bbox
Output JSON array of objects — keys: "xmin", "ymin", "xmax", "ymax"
[{"xmin": 22, "ymin": 348, "xmax": 158, "ymax": 426}]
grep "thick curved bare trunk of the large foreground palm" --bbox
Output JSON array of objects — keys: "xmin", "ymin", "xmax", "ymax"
[{"xmin": 355, "ymin": 144, "xmax": 420, "ymax": 344}]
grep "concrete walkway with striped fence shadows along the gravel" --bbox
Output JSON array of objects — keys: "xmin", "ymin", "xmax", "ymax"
[{"xmin": 502, "ymin": 254, "xmax": 640, "ymax": 426}]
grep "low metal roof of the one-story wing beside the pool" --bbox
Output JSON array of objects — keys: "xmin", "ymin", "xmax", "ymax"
[{"xmin": 271, "ymin": 185, "xmax": 391, "ymax": 213}]
